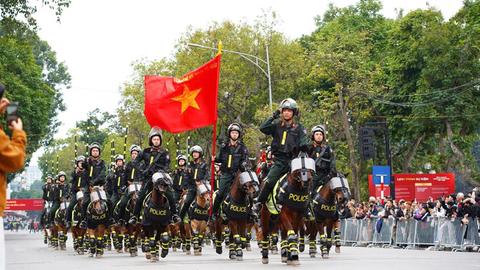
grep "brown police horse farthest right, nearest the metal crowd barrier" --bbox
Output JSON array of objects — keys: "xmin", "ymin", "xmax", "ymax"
[{"xmin": 313, "ymin": 173, "xmax": 350, "ymax": 259}]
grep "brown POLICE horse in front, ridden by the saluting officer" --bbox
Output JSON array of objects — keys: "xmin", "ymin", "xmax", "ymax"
[{"xmin": 260, "ymin": 154, "xmax": 315, "ymax": 265}]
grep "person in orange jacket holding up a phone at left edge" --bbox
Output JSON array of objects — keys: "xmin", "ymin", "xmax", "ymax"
[{"xmin": 0, "ymin": 85, "xmax": 27, "ymax": 268}]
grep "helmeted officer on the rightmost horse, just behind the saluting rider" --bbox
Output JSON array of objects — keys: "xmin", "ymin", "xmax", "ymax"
[{"xmin": 307, "ymin": 125, "xmax": 337, "ymax": 192}]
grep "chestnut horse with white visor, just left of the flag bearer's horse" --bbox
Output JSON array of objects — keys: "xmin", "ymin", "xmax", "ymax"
[{"xmin": 185, "ymin": 183, "xmax": 210, "ymax": 256}]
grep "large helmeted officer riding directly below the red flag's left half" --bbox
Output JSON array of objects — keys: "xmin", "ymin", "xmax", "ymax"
[{"xmin": 129, "ymin": 127, "xmax": 178, "ymax": 224}]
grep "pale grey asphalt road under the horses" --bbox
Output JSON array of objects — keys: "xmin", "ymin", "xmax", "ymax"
[{"xmin": 6, "ymin": 232, "xmax": 480, "ymax": 270}]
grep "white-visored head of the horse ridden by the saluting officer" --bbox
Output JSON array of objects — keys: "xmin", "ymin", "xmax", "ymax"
[{"xmin": 288, "ymin": 153, "xmax": 315, "ymax": 189}]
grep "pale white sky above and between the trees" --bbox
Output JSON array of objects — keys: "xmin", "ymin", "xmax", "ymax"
[{"xmin": 32, "ymin": 0, "xmax": 462, "ymax": 167}]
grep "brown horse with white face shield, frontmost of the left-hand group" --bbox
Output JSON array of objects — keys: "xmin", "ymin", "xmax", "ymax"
[{"xmin": 86, "ymin": 186, "xmax": 110, "ymax": 258}]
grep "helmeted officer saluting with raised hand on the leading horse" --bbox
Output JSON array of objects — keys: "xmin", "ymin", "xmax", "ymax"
[{"xmin": 257, "ymin": 98, "xmax": 308, "ymax": 207}]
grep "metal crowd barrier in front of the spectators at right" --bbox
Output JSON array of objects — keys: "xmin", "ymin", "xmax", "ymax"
[{"xmin": 340, "ymin": 217, "xmax": 480, "ymax": 251}]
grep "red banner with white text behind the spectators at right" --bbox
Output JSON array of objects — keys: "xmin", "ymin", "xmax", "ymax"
[{"xmin": 368, "ymin": 173, "xmax": 455, "ymax": 202}]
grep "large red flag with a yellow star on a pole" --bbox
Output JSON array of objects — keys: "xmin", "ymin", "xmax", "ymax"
[{"xmin": 143, "ymin": 54, "xmax": 221, "ymax": 133}]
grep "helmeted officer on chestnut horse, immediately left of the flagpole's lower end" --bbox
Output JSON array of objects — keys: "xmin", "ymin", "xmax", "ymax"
[{"xmin": 180, "ymin": 145, "xmax": 209, "ymax": 220}]
